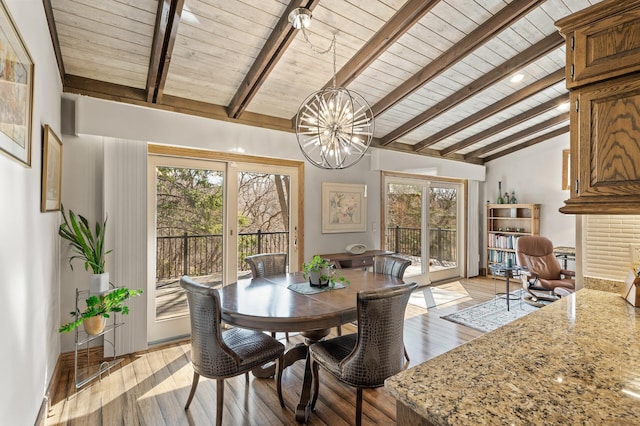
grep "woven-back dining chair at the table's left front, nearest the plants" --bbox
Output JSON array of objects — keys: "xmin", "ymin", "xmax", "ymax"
[{"xmin": 180, "ymin": 275, "xmax": 284, "ymax": 425}]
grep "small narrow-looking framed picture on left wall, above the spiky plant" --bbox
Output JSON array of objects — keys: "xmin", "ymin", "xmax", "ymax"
[{"xmin": 40, "ymin": 124, "xmax": 62, "ymax": 212}]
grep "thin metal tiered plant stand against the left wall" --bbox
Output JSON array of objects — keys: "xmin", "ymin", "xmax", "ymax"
[{"xmin": 74, "ymin": 288, "xmax": 123, "ymax": 390}]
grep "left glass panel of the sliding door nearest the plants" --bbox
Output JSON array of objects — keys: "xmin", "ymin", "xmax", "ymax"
[{"xmin": 148, "ymin": 157, "xmax": 225, "ymax": 342}]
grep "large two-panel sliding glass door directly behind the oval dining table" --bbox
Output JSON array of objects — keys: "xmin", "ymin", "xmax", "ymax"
[{"xmin": 147, "ymin": 151, "xmax": 298, "ymax": 343}]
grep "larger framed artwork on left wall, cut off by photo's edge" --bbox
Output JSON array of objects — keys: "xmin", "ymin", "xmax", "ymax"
[{"xmin": 0, "ymin": 0, "xmax": 33, "ymax": 166}]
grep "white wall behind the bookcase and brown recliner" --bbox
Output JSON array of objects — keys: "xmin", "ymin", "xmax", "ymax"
[{"xmin": 480, "ymin": 133, "xmax": 576, "ymax": 266}]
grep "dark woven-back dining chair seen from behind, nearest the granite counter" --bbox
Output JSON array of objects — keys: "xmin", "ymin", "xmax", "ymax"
[{"xmin": 309, "ymin": 283, "xmax": 418, "ymax": 425}]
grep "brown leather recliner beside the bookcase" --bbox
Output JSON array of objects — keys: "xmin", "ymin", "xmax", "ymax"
[{"xmin": 516, "ymin": 236, "xmax": 576, "ymax": 304}]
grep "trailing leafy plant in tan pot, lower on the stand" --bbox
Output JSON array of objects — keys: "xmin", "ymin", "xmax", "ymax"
[{"xmin": 58, "ymin": 287, "xmax": 142, "ymax": 335}]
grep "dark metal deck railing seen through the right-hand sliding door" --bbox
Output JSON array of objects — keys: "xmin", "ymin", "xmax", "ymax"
[{"xmin": 386, "ymin": 226, "xmax": 458, "ymax": 264}]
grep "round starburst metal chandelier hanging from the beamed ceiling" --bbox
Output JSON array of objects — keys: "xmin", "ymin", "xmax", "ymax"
[{"xmin": 289, "ymin": 8, "xmax": 374, "ymax": 169}]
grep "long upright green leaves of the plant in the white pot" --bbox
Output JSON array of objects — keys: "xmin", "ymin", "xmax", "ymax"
[{"xmin": 58, "ymin": 206, "xmax": 111, "ymax": 274}]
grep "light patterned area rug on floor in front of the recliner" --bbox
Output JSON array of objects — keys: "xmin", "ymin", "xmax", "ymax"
[{"xmin": 441, "ymin": 290, "xmax": 538, "ymax": 332}]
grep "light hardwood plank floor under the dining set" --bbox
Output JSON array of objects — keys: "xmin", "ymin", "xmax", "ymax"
[{"xmin": 46, "ymin": 278, "xmax": 495, "ymax": 426}]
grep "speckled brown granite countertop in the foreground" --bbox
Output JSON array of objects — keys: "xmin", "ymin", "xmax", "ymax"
[{"xmin": 385, "ymin": 289, "xmax": 640, "ymax": 425}]
